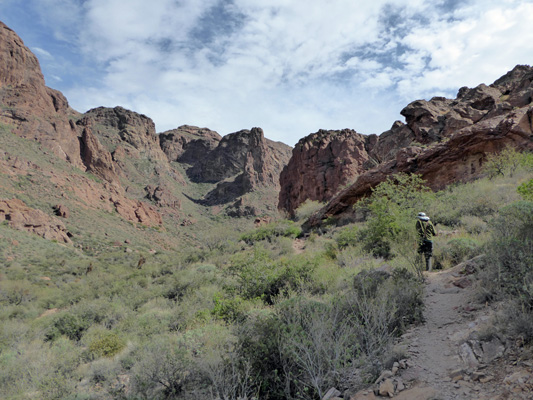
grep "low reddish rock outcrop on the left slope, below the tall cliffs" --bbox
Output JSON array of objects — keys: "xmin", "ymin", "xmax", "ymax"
[{"xmin": 0, "ymin": 199, "xmax": 71, "ymax": 243}]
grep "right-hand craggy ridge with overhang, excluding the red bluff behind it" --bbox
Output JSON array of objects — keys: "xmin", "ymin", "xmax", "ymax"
[{"xmin": 296, "ymin": 66, "xmax": 533, "ymax": 226}]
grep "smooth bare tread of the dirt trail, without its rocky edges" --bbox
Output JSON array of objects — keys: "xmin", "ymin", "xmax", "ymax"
[{"xmin": 394, "ymin": 270, "xmax": 488, "ymax": 399}]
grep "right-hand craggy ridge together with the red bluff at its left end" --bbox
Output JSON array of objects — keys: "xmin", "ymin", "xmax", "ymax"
[{"xmin": 279, "ymin": 65, "xmax": 533, "ymax": 226}]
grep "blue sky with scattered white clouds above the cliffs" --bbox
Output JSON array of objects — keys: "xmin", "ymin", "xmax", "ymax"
[{"xmin": 0, "ymin": 0, "xmax": 533, "ymax": 146}]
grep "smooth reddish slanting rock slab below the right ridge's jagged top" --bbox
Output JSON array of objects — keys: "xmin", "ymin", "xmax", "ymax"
[{"xmin": 308, "ymin": 107, "xmax": 533, "ymax": 227}]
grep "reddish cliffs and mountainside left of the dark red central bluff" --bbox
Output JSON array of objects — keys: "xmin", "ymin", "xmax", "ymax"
[{"xmin": 0, "ymin": 23, "xmax": 291, "ymax": 244}]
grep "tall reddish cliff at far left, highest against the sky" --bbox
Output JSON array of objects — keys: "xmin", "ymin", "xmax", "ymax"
[{"xmin": 0, "ymin": 22, "xmax": 83, "ymax": 168}]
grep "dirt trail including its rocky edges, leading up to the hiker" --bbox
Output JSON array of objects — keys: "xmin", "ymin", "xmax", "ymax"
[{"xmin": 351, "ymin": 266, "xmax": 533, "ymax": 400}]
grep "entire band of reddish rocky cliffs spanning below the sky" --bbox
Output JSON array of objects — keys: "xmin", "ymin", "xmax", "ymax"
[{"xmin": 0, "ymin": 18, "xmax": 533, "ymax": 241}]
